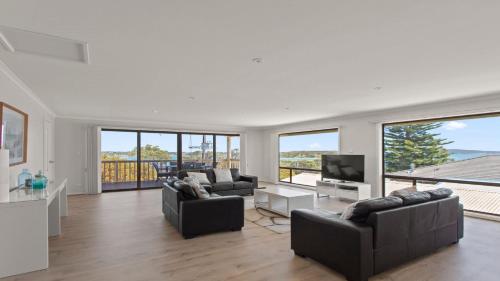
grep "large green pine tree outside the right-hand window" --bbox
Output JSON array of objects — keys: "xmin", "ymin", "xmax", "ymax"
[{"xmin": 384, "ymin": 122, "xmax": 453, "ymax": 172}]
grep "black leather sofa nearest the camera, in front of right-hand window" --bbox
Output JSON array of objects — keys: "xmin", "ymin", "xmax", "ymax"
[{"xmin": 291, "ymin": 197, "xmax": 463, "ymax": 281}]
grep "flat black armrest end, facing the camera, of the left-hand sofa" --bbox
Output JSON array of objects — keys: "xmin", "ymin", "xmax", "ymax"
[{"xmin": 179, "ymin": 196, "xmax": 244, "ymax": 238}]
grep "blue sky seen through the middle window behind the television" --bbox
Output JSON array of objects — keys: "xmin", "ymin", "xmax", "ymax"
[{"xmin": 280, "ymin": 133, "xmax": 339, "ymax": 152}]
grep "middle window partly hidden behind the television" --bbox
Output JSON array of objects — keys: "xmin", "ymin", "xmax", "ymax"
[{"xmin": 279, "ymin": 129, "xmax": 339, "ymax": 186}]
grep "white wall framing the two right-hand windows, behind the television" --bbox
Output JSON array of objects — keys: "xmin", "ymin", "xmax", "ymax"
[{"xmin": 258, "ymin": 94, "xmax": 500, "ymax": 196}]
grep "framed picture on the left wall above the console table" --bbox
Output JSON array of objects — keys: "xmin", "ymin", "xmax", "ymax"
[{"xmin": 0, "ymin": 102, "xmax": 28, "ymax": 166}]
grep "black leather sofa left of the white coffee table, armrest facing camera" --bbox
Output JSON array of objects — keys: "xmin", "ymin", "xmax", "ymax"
[{"xmin": 162, "ymin": 180, "xmax": 244, "ymax": 239}]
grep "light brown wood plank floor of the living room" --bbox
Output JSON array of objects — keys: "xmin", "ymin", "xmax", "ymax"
[{"xmin": 2, "ymin": 185, "xmax": 500, "ymax": 281}]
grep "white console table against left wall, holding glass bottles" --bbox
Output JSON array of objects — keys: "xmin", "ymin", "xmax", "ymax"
[{"xmin": 0, "ymin": 180, "xmax": 68, "ymax": 278}]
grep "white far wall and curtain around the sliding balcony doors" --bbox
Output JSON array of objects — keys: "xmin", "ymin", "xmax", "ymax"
[{"xmin": 56, "ymin": 118, "xmax": 250, "ymax": 194}]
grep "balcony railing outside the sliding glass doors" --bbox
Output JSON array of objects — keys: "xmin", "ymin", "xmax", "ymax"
[{"xmin": 101, "ymin": 159, "xmax": 240, "ymax": 184}]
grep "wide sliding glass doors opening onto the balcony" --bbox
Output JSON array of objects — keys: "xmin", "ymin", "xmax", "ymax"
[{"xmin": 101, "ymin": 129, "xmax": 240, "ymax": 191}]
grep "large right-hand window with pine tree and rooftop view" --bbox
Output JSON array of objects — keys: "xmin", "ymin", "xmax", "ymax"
[{"xmin": 383, "ymin": 114, "xmax": 500, "ymax": 215}]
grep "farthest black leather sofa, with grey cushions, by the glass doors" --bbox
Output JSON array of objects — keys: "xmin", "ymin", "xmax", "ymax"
[{"xmin": 177, "ymin": 169, "xmax": 258, "ymax": 196}]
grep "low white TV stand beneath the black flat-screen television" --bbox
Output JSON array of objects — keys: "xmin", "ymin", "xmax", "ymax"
[{"xmin": 316, "ymin": 180, "xmax": 372, "ymax": 201}]
